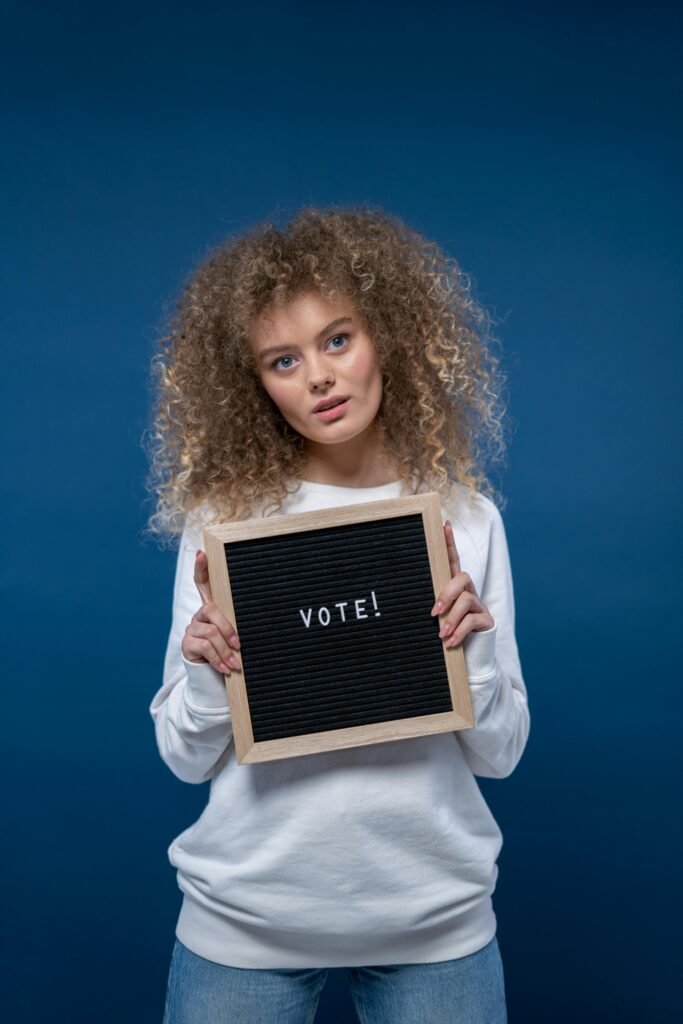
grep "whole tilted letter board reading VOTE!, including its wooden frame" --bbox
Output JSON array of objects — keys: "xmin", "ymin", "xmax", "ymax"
[{"xmin": 203, "ymin": 492, "xmax": 474, "ymax": 764}]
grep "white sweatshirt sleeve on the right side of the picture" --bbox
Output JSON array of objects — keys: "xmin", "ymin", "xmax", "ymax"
[{"xmin": 456, "ymin": 499, "xmax": 529, "ymax": 778}]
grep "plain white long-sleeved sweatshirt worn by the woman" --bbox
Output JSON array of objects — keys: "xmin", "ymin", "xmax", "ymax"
[{"xmin": 150, "ymin": 480, "xmax": 529, "ymax": 968}]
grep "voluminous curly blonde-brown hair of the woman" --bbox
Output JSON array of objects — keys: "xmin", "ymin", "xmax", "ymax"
[{"xmin": 143, "ymin": 205, "xmax": 506, "ymax": 539}]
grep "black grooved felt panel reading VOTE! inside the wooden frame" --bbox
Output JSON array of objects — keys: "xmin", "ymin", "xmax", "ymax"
[{"xmin": 224, "ymin": 514, "xmax": 453, "ymax": 742}]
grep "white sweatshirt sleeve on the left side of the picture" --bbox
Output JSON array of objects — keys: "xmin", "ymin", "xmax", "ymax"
[{"xmin": 150, "ymin": 521, "xmax": 232, "ymax": 782}]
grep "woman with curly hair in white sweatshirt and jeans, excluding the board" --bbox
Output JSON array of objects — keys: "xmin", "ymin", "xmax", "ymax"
[{"xmin": 144, "ymin": 208, "xmax": 529, "ymax": 1024}]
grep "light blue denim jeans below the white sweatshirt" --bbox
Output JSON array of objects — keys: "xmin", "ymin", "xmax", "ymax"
[{"xmin": 163, "ymin": 936, "xmax": 507, "ymax": 1024}]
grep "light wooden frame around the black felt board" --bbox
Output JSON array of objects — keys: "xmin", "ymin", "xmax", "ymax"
[{"xmin": 203, "ymin": 492, "xmax": 474, "ymax": 764}]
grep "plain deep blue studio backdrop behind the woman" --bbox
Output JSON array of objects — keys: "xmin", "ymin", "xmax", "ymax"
[{"xmin": 1, "ymin": 0, "xmax": 683, "ymax": 1024}]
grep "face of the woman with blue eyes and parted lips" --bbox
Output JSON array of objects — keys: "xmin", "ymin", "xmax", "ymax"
[{"xmin": 250, "ymin": 293, "xmax": 382, "ymax": 444}]
